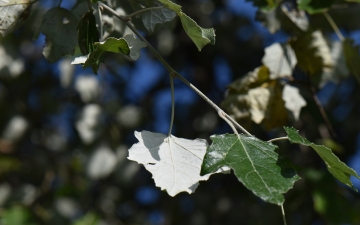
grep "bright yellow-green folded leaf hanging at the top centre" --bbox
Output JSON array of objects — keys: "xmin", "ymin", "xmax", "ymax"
[{"xmin": 159, "ymin": 0, "xmax": 215, "ymax": 51}]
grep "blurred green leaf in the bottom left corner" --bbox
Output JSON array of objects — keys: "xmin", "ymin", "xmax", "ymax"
[{"xmin": 1, "ymin": 206, "xmax": 35, "ymax": 225}]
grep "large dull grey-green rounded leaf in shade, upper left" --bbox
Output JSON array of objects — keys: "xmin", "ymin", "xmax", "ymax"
[{"xmin": 40, "ymin": 7, "xmax": 77, "ymax": 63}]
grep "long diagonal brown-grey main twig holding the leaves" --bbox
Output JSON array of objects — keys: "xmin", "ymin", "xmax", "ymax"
[{"xmin": 98, "ymin": 2, "xmax": 252, "ymax": 136}]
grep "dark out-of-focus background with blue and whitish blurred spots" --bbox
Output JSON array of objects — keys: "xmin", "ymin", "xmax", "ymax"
[{"xmin": 0, "ymin": 0, "xmax": 360, "ymax": 225}]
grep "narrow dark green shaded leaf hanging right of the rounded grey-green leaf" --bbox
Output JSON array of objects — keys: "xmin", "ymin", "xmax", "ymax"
[{"xmin": 78, "ymin": 12, "xmax": 99, "ymax": 55}]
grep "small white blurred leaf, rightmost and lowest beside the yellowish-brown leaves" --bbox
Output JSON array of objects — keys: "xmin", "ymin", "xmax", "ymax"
[{"xmin": 282, "ymin": 84, "xmax": 306, "ymax": 120}]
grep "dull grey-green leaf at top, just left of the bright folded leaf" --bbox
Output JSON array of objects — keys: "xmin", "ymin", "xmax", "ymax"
[{"xmin": 141, "ymin": 8, "xmax": 176, "ymax": 32}]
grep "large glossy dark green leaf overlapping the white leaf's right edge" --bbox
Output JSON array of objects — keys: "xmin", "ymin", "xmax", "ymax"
[{"xmin": 201, "ymin": 134, "xmax": 300, "ymax": 205}]
